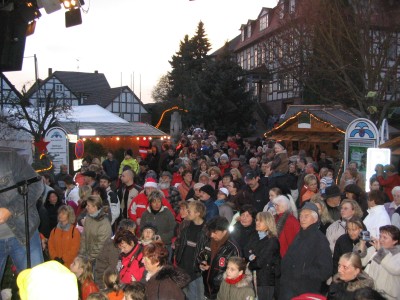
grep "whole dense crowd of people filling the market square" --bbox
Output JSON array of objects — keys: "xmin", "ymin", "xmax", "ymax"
[{"xmin": 0, "ymin": 130, "xmax": 400, "ymax": 300}]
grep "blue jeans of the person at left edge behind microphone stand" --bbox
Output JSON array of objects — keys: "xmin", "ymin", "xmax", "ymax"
[{"xmin": 0, "ymin": 230, "xmax": 43, "ymax": 281}]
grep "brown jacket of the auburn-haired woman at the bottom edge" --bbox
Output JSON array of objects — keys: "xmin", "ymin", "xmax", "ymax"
[{"xmin": 145, "ymin": 266, "xmax": 190, "ymax": 300}]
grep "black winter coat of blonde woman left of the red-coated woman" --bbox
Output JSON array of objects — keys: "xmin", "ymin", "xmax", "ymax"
[{"xmin": 245, "ymin": 234, "xmax": 281, "ymax": 286}]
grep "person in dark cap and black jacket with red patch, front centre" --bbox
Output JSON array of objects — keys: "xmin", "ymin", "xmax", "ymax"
[{"xmin": 197, "ymin": 216, "xmax": 241, "ymax": 299}]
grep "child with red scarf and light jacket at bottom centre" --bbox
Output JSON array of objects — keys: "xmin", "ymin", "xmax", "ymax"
[{"xmin": 217, "ymin": 256, "xmax": 255, "ymax": 300}]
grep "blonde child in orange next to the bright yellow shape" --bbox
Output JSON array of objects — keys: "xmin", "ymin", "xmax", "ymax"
[{"xmin": 70, "ymin": 255, "xmax": 99, "ymax": 300}]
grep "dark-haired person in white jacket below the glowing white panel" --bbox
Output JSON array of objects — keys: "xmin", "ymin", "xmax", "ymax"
[{"xmin": 364, "ymin": 191, "xmax": 391, "ymax": 238}]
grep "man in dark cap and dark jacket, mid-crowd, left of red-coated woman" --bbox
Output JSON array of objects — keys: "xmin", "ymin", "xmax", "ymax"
[{"xmin": 244, "ymin": 170, "xmax": 269, "ymax": 212}]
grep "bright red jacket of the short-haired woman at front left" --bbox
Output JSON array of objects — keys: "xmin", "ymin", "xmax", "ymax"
[{"xmin": 119, "ymin": 244, "xmax": 144, "ymax": 284}]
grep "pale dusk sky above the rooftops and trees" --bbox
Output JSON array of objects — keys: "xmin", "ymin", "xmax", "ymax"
[{"xmin": 5, "ymin": 0, "xmax": 278, "ymax": 103}]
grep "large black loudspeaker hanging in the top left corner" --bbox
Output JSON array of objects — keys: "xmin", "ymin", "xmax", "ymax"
[{"xmin": 0, "ymin": 11, "xmax": 28, "ymax": 72}]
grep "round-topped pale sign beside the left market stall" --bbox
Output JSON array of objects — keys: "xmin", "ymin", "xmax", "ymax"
[{"xmin": 45, "ymin": 127, "xmax": 69, "ymax": 174}]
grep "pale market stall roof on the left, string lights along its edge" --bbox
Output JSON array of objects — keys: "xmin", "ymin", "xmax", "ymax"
[{"xmin": 58, "ymin": 105, "xmax": 168, "ymax": 137}]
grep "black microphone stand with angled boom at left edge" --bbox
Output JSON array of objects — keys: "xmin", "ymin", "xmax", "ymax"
[{"xmin": 0, "ymin": 176, "xmax": 41, "ymax": 269}]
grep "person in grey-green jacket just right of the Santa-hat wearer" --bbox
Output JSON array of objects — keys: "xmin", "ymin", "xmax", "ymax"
[{"xmin": 141, "ymin": 189, "xmax": 176, "ymax": 252}]
